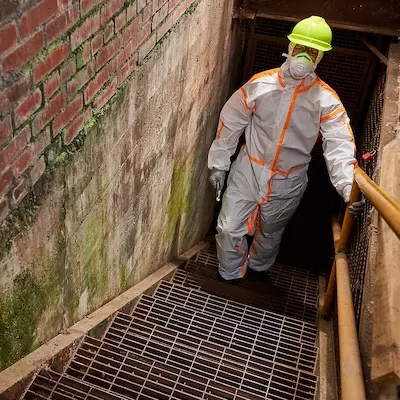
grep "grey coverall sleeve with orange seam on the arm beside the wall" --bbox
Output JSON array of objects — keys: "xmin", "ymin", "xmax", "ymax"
[{"xmin": 208, "ymin": 84, "xmax": 255, "ymax": 171}]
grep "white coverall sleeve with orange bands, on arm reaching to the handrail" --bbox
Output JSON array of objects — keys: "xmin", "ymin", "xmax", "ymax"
[{"xmin": 320, "ymin": 95, "xmax": 357, "ymax": 197}]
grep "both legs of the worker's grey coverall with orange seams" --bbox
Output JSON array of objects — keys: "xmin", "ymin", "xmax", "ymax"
[{"xmin": 216, "ymin": 169, "xmax": 307, "ymax": 280}]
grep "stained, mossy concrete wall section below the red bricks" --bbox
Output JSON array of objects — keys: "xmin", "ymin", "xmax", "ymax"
[{"xmin": 0, "ymin": 0, "xmax": 241, "ymax": 369}]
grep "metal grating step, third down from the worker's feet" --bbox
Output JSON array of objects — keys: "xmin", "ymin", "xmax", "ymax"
[{"xmin": 132, "ymin": 296, "xmax": 317, "ymax": 373}]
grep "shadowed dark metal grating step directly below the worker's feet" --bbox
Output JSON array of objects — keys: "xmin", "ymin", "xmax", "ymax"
[{"xmin": 172, "ymin": 264, "xmax": 318, "ymax": 323}]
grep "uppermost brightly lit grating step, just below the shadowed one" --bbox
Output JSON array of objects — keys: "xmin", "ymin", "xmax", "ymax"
[{"xmin": 154, "ymin": 282, "xmax": 317, "ymax": 345}]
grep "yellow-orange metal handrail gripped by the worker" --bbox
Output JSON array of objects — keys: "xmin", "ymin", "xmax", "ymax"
[{"xmin": 321, "ymin": 167, "xmax": 400, "ymax": 400}]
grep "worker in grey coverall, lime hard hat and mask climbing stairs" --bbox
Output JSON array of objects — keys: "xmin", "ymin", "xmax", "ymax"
[{"xmin": 208, "ymin": 16, "xmax": 364, "ymax": 283}]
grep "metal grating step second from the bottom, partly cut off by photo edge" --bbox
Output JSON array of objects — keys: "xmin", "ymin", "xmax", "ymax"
[{"xmin": 67, "ymin": 337, "xmax": 261, "ymax": 400}]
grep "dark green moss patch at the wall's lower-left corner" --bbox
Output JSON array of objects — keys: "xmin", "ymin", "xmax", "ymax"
[{"xmin": 0, "ymin": 271, "xmax": 47, "ymax": 370}]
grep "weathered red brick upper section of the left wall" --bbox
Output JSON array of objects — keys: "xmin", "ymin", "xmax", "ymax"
[{"xmin": 0, "ymin": 0, "xmax": 193, "ymax": 221}]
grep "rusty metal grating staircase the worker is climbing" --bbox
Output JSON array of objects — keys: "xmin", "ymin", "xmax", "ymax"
[{"xmin": 23, "ymin": 242, "xmax": 318, "ymax": 400}]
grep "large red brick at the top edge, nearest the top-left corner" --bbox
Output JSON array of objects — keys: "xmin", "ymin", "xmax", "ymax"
[{"xmin": 19, "ymin": 0, "xmax": 58, "ymax": 37}]
